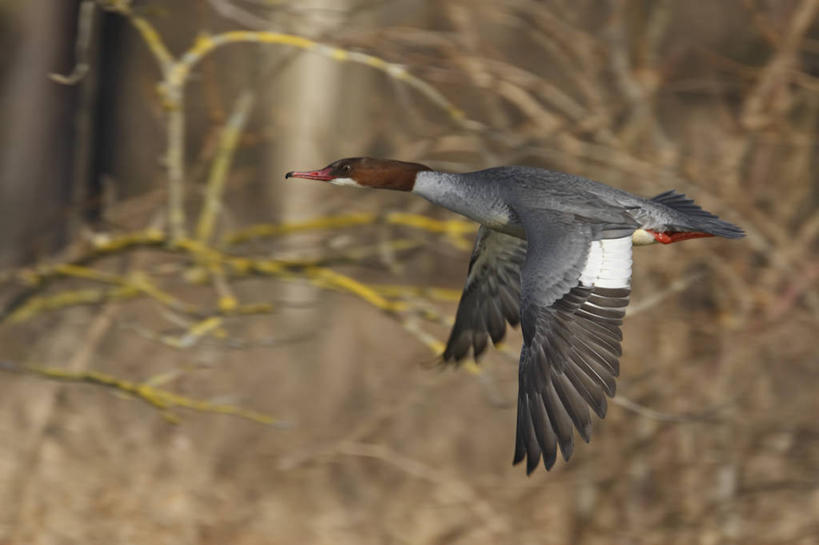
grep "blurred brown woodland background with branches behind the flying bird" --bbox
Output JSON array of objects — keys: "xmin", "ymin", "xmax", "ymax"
[{"xmin": 0, "ymin": 0, "xmax": 819, "ymax": 545}]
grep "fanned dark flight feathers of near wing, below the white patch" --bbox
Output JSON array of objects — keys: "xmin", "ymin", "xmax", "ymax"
[{"xmin": 514, "ymin": 286, "xmax": 629, "ymax": 472}]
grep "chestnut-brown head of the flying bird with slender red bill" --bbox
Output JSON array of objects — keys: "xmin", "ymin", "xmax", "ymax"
[{"xmin": 285, "ymin": 157, "xmax": 432, "ymax": 191}]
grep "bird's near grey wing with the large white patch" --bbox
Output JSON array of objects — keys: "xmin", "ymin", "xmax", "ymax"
[{"xmin": 514, "ymin": 210, "xmax": 631, "ymax": 473}]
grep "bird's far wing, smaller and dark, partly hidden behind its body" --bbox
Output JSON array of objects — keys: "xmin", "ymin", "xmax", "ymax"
[{"xmin": 443, "ymin": 225, "xmax": 526, "ymax": 361}]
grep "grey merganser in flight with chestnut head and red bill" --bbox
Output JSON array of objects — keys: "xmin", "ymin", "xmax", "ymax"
[{"xmin": 285, "ymin": 157, "xmax": 745, "ymax": 474}]
